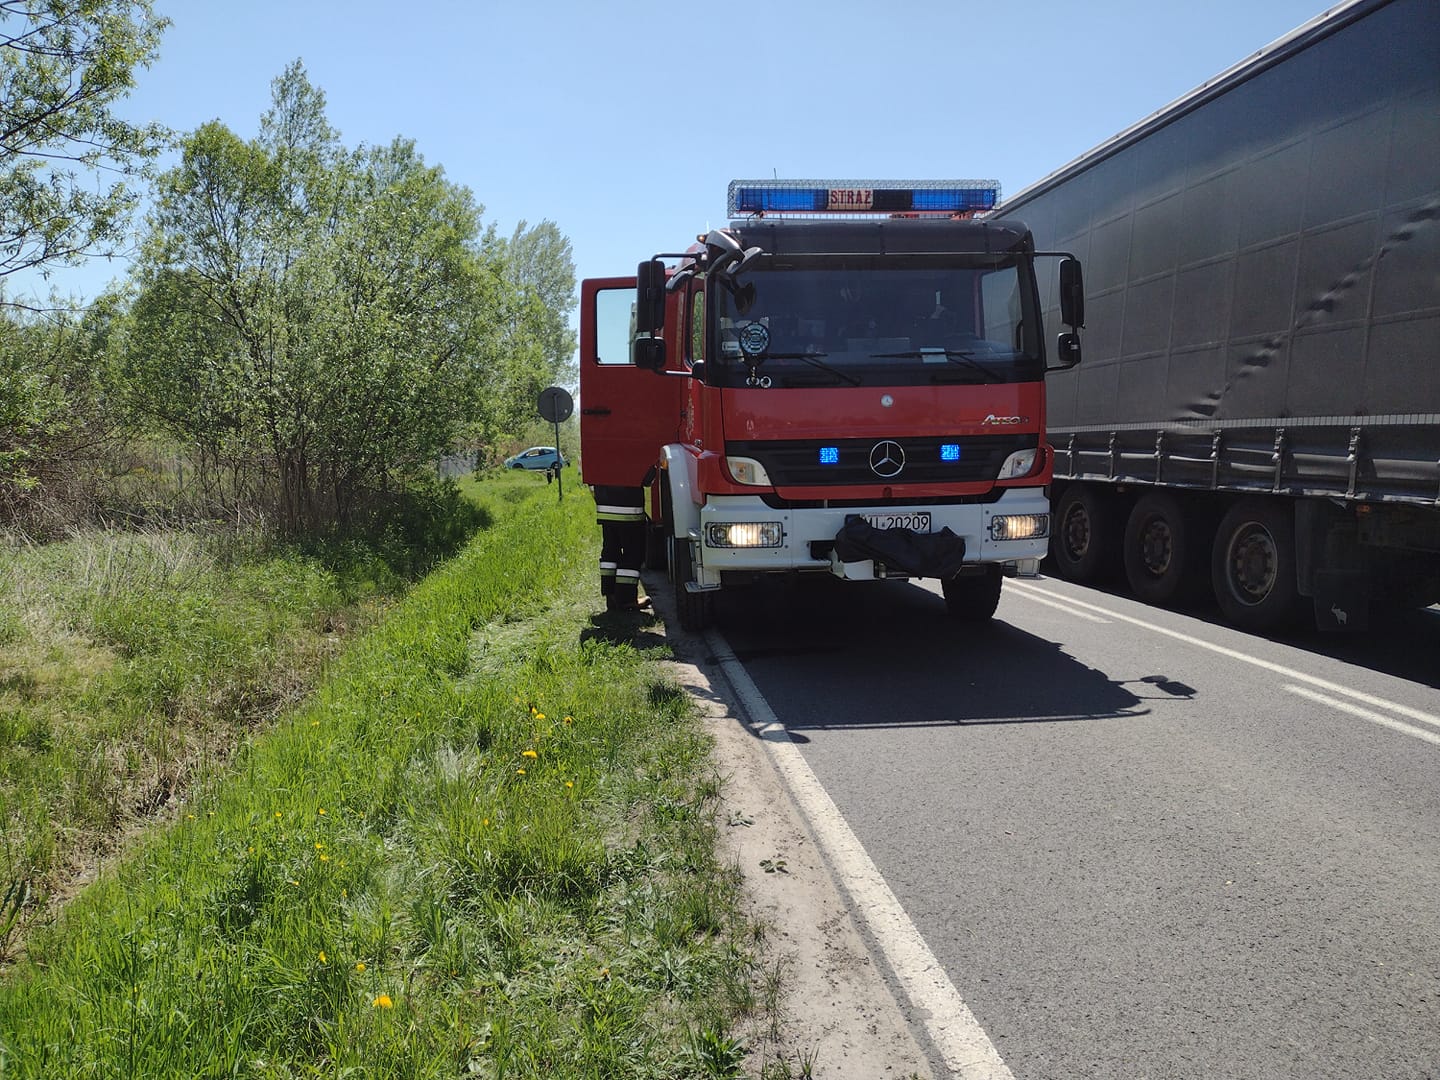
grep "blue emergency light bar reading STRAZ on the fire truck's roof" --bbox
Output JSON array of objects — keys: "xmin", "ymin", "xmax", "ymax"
[{"xmin": 729, "ymin": 180, "xmax": 999, "ymax": 217}]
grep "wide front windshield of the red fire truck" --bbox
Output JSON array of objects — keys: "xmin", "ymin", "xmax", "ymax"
[{"xmin": 706, "ymin": 256, "xmax": 1043, "ymax": 387}]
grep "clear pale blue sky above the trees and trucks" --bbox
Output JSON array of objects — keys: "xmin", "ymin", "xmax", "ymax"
[{"xmin": 10, "ymin": 0, "xmax": 1339, "ymax": 308}]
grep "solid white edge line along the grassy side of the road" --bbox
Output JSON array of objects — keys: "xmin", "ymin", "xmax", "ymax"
[{"xmin": 706, "ymin": 631, "xmax": 1014, "ymax": 1080}]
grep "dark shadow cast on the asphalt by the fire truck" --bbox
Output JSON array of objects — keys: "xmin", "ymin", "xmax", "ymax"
[{"xmin": 662, "ymin": 579, "xmax": 1169, "ymax": 740}]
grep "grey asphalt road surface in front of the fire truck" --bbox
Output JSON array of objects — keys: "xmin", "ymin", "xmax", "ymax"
[{"xmin": 721, "ymin": 579, "xmax": 1440, "ymax": 1080}]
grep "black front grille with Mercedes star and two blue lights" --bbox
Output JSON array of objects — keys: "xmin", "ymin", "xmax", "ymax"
[{"xmin": 724, "ymin": 433, "xmax": 1040, "ymax": 487}]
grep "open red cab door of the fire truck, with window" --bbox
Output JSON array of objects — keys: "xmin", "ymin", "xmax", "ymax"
[{"xmin": 580, "ymin": 278, "xmax": 685, "ymax": 487}]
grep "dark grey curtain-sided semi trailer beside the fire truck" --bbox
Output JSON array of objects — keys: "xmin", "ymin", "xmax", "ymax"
[{"xmin": 998, "ymin": 0, "xmax": 1440, "ymax": 632}]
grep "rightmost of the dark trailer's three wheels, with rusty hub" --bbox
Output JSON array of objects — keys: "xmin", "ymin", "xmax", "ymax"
[{"xmin": 1210, "ymin": 498, "xmax": 1300, "ymax": 634}]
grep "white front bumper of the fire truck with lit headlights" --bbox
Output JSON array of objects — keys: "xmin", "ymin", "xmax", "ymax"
[{"xmin": 691, "ymin": 488, "xmax": 1050, "ymax": 586}]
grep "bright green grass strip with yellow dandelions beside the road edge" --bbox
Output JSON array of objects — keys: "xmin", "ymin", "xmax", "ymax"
[{"xmin": 0, "ymin": 478, "xmax": 757, "ymax": 1077}]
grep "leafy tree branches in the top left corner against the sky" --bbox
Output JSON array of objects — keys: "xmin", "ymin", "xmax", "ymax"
[{"xmin": 0, "ymin": 0, "xmax": 168, "ymax": 296}]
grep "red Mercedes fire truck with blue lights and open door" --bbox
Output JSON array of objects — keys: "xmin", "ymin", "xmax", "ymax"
[{"xmin": 580, "ymin": 180, "xmax": 1084, "ymax": 629}]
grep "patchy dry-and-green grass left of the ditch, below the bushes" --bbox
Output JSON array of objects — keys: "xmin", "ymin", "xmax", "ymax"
[{"xmin": 0, "ymin": 530, "xmax": 403, "ymax": 944}]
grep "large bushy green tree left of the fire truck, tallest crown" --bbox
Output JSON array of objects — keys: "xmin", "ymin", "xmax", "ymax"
[{"xmin": 127, "ymin": 62, "xmax": 518, "ymax": 531}]
